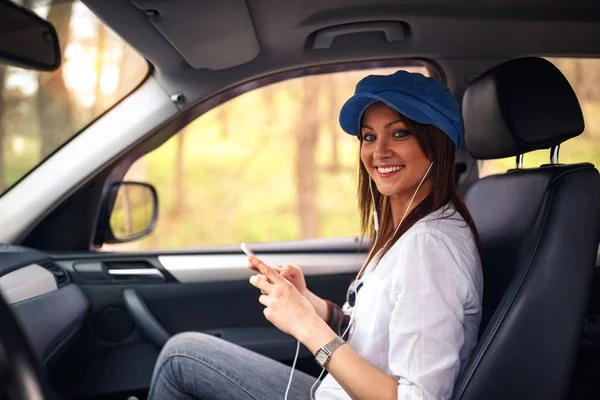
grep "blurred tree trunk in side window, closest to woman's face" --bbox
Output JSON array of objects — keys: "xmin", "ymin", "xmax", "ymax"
[{"xmin": 296, "ymin": 77, "xmax": 319, "ymax": 239}]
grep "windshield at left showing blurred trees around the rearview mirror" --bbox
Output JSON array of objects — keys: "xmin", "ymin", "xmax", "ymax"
[{"xmin": 0, "ymin": 0, "xmax": 148, "ymax": 195}]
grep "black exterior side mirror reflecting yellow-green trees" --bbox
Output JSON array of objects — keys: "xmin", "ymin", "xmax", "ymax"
[{"xmin": 95, "ymin": 182, "xmax": 158, "ymax": 245}]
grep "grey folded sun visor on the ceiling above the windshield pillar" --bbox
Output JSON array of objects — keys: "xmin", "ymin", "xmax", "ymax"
[{"xmin": 131, "ymin": 0, "xmax": 260, "ymax": 70}]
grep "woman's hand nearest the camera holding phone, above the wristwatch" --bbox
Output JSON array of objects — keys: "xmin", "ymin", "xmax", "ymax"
[{"xmin": 248, "ymin": 257, "xmax": 319, "ymax": 339}]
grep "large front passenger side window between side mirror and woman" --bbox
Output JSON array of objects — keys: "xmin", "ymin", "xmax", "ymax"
[{"xmin": 104, "ymin": 65, "xmax": 428, "ymax": 250}]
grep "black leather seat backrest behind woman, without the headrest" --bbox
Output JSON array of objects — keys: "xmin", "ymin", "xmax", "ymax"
[{"xmin": 454, "ymin": 164, "xmax": 600, "ymax": 400}]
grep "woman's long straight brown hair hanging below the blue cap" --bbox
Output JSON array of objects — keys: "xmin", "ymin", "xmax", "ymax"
[{"xmin": 358, "ymin": 115, "xmax": 481, "ymax": 276}]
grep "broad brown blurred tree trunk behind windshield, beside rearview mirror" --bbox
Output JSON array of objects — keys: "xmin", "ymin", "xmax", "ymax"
[{"xmin": 36, "ymin": 0, "xmax": 74, "ymax": 158}]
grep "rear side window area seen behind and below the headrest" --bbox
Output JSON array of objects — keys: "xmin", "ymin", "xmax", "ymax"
[{"xmin": 479, "ymin": 58, "xmax": 600, "ymax": 177}]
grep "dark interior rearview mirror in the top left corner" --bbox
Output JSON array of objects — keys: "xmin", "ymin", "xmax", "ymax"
[{"xmin": 0, "ymin": 0, "xmax": 60, "ymax": 71}]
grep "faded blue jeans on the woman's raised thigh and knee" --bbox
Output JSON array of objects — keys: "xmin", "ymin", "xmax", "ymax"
[{"xmin": 148, "ymin": 332, "xmax": 316, "ymax": 400}]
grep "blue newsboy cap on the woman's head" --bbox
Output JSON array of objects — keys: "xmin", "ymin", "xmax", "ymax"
[{"xmin": 340, "ymin": 71, "xmax": 465, "ymax": 149}]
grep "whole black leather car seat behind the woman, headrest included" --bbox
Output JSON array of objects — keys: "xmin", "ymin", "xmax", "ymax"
[{"xmin": 453, "ymin": 58, "xmax": 600, "ymax": 400}]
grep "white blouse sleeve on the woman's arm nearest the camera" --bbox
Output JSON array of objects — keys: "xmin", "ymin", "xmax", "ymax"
[{"xmin": 388, "ymin": 230, "xmax": 470, "ymax": 400}]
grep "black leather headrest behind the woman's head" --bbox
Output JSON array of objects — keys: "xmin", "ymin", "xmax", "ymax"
[{"xmin": 462, "ymin": 57, "xmax": 584, "ymax": 159}]
